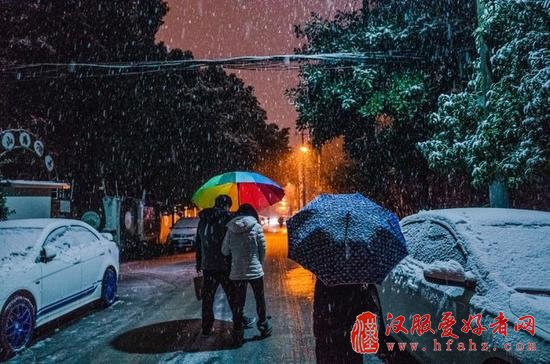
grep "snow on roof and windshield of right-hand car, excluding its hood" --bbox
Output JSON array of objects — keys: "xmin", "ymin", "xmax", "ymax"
[{"xmin": 410, "ymin": 208, "xmax": 550, "ymax": 289}]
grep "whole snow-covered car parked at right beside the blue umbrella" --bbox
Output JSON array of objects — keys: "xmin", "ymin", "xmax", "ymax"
[{"xmin": 373, "ymin": 208, "xmax": 550, "ymax": 363}]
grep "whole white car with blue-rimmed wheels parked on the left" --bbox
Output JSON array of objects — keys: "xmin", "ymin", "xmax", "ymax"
[{"xmin": 0, "ymin": 219, "xmax": 119, "ymax": 358}]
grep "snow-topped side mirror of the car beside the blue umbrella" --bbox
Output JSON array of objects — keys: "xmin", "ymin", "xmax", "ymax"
[{"xmin": 424, "ymin": 260, "xmax": 476, "ymax": 291}]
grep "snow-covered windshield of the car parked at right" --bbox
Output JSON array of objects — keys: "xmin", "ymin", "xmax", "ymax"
[{"xmin": 470, "ymin": 224, "xmax": 550, "ymax": 288}]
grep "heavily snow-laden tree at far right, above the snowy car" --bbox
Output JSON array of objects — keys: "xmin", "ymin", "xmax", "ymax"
[{"xmin": 419, "ymin": 0, "xmax": 550, "ymax": 199}]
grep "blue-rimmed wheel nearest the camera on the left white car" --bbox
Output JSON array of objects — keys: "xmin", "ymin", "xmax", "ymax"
[{"xmin": 0, "ymin": 295, "xmax": 36, "ymax": 358}]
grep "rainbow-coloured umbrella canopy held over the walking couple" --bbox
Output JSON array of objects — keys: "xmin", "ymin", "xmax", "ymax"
[{"xmin": 192, "ymin": 172, "xmax": 285, "ymax": 210}]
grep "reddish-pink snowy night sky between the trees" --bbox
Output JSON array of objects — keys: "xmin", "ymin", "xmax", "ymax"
[{"xmin": 157, "ymin": 0, "xmax": 361, "ymax": 143}]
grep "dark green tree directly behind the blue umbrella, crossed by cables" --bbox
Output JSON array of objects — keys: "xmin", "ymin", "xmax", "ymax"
[{"xmin": 291, "ymin": 0, "xmax": 475, "ymax": 214}]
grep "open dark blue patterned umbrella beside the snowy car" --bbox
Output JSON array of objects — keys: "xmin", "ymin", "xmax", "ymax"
[{"xmin": 287, "ymin": 193, "xmax": 407, "ymax": 286}]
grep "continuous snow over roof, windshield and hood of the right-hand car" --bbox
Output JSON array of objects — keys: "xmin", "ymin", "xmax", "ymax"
[{"xmin": 402, "ymin": 208, "xmax": 550, "ymax": 340}]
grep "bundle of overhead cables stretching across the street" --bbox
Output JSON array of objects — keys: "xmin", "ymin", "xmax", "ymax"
[{"xmin": 0, "ymin": 52, "xmax": 422, "ymax": 83}]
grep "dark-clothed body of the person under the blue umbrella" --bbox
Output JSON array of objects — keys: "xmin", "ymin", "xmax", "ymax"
[{"xmin": 313, "ymin": 279, "xmax": 371, "ymax": 364}]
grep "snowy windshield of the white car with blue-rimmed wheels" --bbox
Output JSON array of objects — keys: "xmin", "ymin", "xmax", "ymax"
[{"xmin": 0, "ymin": 227, "xmax": 42, "ymax": 261}]
